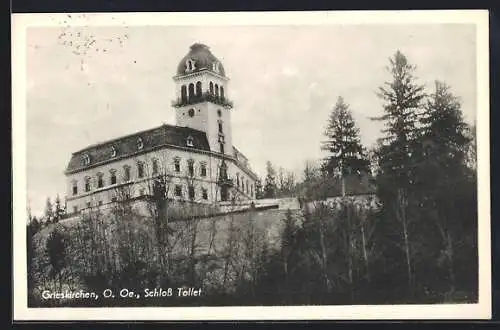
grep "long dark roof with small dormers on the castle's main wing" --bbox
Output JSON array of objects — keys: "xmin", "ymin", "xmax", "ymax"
[{"xmin": 66, "ymin": 124, "xmax": 210, "ymax": 173}]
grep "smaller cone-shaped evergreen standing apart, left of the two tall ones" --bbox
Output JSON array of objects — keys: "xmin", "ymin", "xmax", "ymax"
[{"xmin": 321, "ymin": 96, "xmax": 369, "ymax": 195}]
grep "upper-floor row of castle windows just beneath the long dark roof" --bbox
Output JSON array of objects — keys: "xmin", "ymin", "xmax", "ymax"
[{"xmin": 72, "ymin": 158, "xmax": 207, "ymax": 195}]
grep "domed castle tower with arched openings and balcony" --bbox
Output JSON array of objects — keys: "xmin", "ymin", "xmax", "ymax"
[{"xmin": 173, "ymin": 43, "xmax": 233, "ymax": 154}]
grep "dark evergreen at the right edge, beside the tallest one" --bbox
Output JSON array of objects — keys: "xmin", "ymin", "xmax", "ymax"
[{"xmin": 418, "ymin": 81, "xmax": 477, "ymax": 291}]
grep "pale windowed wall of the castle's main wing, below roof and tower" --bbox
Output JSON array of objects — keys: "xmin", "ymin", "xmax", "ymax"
[{"xmin": 67, "ymin": 148, "xmax": 255, "ymax": 212}]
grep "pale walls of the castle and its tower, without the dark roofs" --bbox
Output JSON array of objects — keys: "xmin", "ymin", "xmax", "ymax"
[{"xmin": 66, "ymin": 43, "xmax": 257, "ymax": 213}]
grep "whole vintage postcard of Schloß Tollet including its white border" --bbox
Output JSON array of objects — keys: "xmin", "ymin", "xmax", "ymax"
[{"xmin": 12, "ymin": 11, "xmax": 491, "ymax": 320}]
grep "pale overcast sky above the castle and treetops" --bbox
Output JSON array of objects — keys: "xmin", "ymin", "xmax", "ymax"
[{"xmin": 27, "ymin": 25, "xmax": 477, "ymax": 214}]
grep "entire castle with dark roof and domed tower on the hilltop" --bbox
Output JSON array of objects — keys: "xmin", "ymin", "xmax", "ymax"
[{"xmin": 65, "ymin": 43, "xmax": 257, "ymax": 213}]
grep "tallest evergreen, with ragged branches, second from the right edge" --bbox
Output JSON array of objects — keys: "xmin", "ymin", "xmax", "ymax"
[{"xmin": 373, "ymin": 51, "xmax": 425, "ymax": 294}]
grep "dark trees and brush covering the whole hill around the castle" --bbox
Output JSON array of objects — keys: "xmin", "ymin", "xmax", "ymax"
[{"xmin": 27, "ymin": 52, "xmax": 478, "ymax": 307}]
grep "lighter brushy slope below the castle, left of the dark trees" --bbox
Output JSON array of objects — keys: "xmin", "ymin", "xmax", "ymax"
[{"xmin": 31, "ymin": 203, "xmax": 301, "ymax": 306}]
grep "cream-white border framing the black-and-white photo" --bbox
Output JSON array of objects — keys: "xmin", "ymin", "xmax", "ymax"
[{"xmin": 12, "ymin": 10, "xmax": 491, "ymax": 320}]
